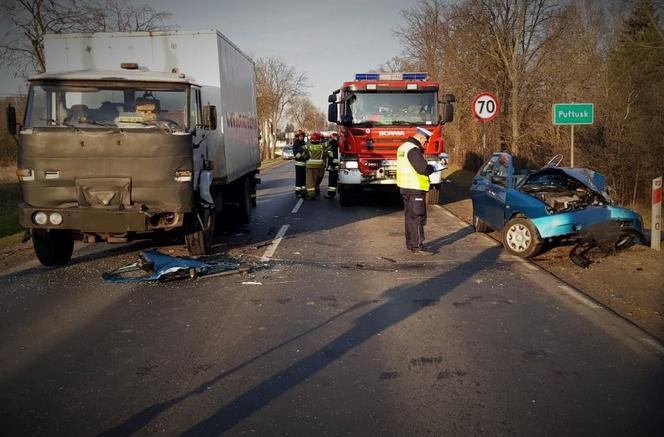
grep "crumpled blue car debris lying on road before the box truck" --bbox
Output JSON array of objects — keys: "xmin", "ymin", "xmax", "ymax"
[{"xmin": 101, "ymin": 250, "xmax": 249, "ymax": 283}]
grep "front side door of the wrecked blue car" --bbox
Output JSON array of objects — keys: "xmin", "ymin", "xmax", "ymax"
[{"xmin": 484, "ymin": 153, "xmax": 514, "ymax": 230}]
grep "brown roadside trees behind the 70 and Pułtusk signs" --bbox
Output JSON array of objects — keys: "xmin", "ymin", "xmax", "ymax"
[{"xmin": 381, "ymin": 0, "xmax": 664, "ymax": 204}]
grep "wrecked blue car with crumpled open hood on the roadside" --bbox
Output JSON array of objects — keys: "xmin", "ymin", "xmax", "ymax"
[{"xmin": 470, "ymin": 153, "xmax": 643, "ymax": 258}]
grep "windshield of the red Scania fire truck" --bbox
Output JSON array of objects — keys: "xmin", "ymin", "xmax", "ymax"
[{"xmin": 347, "ymin": 91, "xmax": 438, "ymax": 125}]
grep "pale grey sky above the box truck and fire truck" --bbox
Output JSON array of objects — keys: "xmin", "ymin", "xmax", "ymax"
[{"xmin": 0, "ymin": 0, "xmax": 417, "ymax": 110}]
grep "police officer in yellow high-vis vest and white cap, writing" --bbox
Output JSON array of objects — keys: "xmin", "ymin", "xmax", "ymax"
[{"xmin": 397, "ymin": 127, "xmax": 443, "ymax": 255}]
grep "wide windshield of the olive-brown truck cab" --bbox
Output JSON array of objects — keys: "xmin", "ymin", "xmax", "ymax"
[{"xmin": 26, "ymin": 84, "xmax": 189, "ymax": 131}]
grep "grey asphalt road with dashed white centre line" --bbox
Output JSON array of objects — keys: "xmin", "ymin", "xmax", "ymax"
[{"xmin": 0, "ymin": 162, "xmax": 664, "ymax": 436}]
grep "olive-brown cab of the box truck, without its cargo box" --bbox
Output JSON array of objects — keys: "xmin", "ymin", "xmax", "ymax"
[{"xmin": 17, "ymin": 70, "xmax": 210, "ymax": 265}]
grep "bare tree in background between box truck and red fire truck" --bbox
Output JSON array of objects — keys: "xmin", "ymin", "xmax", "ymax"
[{"xmin": 256, "ymin": 57, "xmax": 308, "ymax": 158}]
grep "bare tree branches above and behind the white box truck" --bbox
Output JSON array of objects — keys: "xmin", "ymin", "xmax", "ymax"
[{"xmin": 0, "ymin": 0, "xmax": 171, "ymax": 76}]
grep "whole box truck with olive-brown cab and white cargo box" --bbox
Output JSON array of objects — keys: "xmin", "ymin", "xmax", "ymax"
[{"xmin": 8, "ymin": 30, "xmax": 260, "ymax": 265}]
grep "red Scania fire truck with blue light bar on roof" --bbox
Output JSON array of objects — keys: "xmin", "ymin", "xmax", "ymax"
[{"xmin": 328, "ymin": 73, "xmax": 455, "ymax": 206}]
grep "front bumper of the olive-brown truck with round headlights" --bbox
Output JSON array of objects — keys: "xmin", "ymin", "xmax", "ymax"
[{"xmin": 19, "ymin": 204, "xmax": 170, "ymax": 234}]
